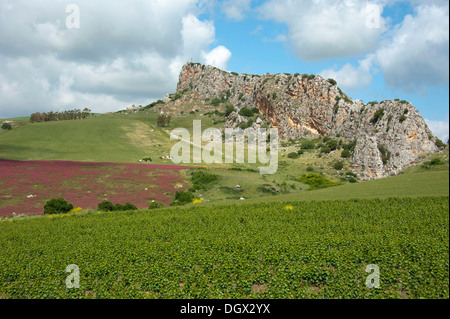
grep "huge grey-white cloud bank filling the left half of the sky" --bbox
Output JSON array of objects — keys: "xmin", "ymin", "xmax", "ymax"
[{"xmin": 0, "ymin": 0, "xmax": 231, "ymax": 118}]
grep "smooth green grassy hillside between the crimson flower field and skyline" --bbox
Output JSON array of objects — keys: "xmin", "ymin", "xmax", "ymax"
[{"xmin": 0, "ymin": 117, "xmax": 174, "ymax": 163}]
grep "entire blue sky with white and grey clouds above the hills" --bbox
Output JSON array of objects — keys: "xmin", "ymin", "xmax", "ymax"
[{"xmin": 0, "ymin": 0, "xmax": 449, "ymax": 141}]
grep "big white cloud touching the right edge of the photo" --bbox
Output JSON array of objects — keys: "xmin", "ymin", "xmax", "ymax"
[{"xmin": 375, "ymin": 2, "xmax": 449, "ymax": 91}]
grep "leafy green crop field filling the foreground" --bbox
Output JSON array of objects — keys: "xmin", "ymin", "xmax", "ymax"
[{"xmin": 0, "ymin": 196, "xmax": 449, "ymax": 299}]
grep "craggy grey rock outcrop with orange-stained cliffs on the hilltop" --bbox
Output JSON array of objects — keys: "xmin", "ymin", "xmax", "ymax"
[{"xmin": 167, "ymin": 63, "xmax": 438, "ymax": 180}]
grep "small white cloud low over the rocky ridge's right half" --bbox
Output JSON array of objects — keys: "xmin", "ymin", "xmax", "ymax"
[{"xmin": 319, "ymin": 56, "xmax": 372, "ymax": 89}]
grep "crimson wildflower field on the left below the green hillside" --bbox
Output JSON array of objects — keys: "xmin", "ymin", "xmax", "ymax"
[{"xmin": 0, "ymin": 160, "xmax": 192, "ymax": 216}]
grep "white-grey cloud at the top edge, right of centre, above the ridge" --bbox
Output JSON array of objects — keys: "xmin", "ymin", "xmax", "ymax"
[{"xmin": 260, "ymin": 0, "xmax": 386, "ymax": 61}]
